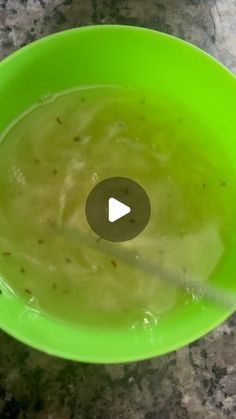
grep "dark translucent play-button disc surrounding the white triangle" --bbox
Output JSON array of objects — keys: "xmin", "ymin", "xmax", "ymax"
[{"xmin": 85, "ymin": 177, "xmax": 151, "ymax": 242}]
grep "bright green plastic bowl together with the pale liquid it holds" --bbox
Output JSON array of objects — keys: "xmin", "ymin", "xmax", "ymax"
[{"xmin": 0, "ymin": 26, "xmax": 236, "ymax": 362}]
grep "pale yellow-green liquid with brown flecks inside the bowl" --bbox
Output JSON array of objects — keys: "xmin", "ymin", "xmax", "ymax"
[{"xmin": 0, "ymin": 87, "xmax": 235, "ymax": 327}]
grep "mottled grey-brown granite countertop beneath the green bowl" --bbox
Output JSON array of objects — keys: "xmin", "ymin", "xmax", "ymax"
[{"xmin": 0, "ymin": 0, "xmax": 236, "ymax": 419}]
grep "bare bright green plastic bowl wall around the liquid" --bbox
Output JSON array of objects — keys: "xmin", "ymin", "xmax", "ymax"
[{"xmin": 0, "ymin": 26, "xmax": 236, "ymax": 363}]
